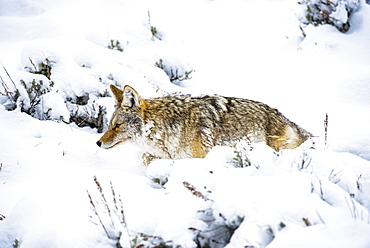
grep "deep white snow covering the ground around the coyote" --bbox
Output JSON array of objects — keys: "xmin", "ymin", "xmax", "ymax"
[{"xmin": 0, "ymin": 0, "xmax": 370, "ymax": 248}]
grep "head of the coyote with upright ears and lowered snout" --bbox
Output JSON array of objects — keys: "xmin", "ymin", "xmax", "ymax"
[{"xmin": 96, "ymin": 85, "xmax": 145, "ymax": 149}]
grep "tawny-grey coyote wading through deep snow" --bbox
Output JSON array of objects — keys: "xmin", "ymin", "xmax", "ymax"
[{"xmin": 96, "ymin": 85, "xmax": 311, "ymax": 159}]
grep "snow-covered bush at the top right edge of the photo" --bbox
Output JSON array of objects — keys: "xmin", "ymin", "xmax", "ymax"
[{"xmin": 298, "ymin": 0, "xmax": 359, "ymax": 33}]
